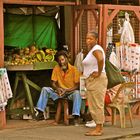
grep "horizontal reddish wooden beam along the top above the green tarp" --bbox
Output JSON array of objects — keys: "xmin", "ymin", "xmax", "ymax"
[{"xmin": 3, "ymin": 0, "xmax": 76, "ymax": 6}]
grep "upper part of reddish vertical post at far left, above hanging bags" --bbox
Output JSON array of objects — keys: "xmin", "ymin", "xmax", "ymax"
[{"xmin": 0, "ymin": 0, "xmax": 4, "ymax": 67}]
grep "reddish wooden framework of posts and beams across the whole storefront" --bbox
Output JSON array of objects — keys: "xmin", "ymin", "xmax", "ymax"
[{"xmin": 0, "ymin": 0, "xmax": 140, "ymax": 129}]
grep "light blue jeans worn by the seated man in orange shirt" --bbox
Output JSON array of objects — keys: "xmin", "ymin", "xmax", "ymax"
[{"xmin": 36, "ymin": 87, "xmax": 82, "ymax": 116}]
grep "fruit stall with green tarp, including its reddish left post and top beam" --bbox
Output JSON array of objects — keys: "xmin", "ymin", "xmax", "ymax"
[{"xmin": 0, "ymin": 0, "xmax": 75, "ymax": 127}]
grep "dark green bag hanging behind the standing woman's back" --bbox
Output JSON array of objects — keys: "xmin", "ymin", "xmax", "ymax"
[{"xmin": 105, "ymin": 59, "xmax": 125, "ymax": 89}]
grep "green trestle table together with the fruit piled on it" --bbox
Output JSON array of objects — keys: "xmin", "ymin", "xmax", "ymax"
[{"xmin": 5, "ymin": 46, "xmax": 57, "ymax": 115}]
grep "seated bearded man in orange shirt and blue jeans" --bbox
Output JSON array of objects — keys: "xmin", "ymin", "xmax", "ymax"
[{"xmin": 36, "ymin": 51, "xmax": 81, "ymax": 123}]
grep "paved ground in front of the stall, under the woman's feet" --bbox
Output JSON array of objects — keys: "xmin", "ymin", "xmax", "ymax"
[{"xmin": 0, "ymin": 119, "xmax": 140, "ymax": 140}]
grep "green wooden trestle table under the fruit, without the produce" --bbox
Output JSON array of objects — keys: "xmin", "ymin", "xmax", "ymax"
[{"xmin": 6, "ymin": 61, "xmax": 57, "ymax": 116}]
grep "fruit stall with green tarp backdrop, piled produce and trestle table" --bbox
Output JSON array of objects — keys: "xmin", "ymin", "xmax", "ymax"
[{"xmin": 4, "ymin": 3, "xmax": 58, "ymax": 118}]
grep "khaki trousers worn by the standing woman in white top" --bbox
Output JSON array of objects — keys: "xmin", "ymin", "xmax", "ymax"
[{"xmin": 86, "ymin": 73, "xmax": 108, "ymax": 124}]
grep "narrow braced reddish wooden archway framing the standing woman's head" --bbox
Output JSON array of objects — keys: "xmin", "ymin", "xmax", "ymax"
[{"xmin": 74, "ymin": 5, "xmax": 102, "ymax": 53}]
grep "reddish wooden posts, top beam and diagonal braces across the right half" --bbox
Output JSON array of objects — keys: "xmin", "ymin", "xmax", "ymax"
[{"xmin": 74, "ymin": 4, "xmax": 140, "ymax": 53}]
